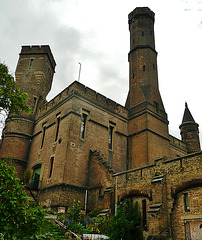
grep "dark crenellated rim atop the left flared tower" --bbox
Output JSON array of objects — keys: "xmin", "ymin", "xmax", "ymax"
[{"xmin": 20, "ymin": 45, "xmax": 56, "ymax": 70}]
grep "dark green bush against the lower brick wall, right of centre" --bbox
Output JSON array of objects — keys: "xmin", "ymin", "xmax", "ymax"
[{"xmin": 109, "ymin": 199, "xmax": 141, "ymax": 240}]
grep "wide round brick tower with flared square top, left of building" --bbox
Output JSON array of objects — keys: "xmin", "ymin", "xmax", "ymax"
[{"xmin": 0, "ymin": 45, "xmax": 56, "ymax": 177}]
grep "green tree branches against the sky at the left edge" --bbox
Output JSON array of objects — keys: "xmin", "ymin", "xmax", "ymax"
[{"xmin": 0, "ymin": 63, "xmax": 31, "ymax": 115}]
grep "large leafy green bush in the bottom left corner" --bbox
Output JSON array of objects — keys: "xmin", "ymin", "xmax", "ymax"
[{"xmin": 0, "ymin": 159, "xmax": 44, "ymax": 239}]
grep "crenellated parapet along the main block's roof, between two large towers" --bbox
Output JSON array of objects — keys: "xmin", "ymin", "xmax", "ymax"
[{"xmin": 38, "ymin": 81, "xmax": 128, "ymax": 117}]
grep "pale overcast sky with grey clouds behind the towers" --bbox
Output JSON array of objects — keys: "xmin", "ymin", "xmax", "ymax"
[{"xmin": 0, "ymin": 0, "xmax": 202, "ymax": 142}]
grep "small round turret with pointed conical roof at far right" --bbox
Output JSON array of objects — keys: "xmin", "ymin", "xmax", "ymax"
[{"xmin": 180, "ymin": 103, "xmax": 201, "ymax": 153}]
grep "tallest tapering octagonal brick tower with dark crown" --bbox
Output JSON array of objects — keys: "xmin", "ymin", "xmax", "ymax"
[{"xmin": 126, "ymin": 7, "xmax": 170, "ymax": 168}]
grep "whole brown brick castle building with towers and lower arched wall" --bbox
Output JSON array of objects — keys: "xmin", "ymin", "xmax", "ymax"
[{"xmin": 0, "ymin": 7, "xmax": 202, "ymax": 240}]
